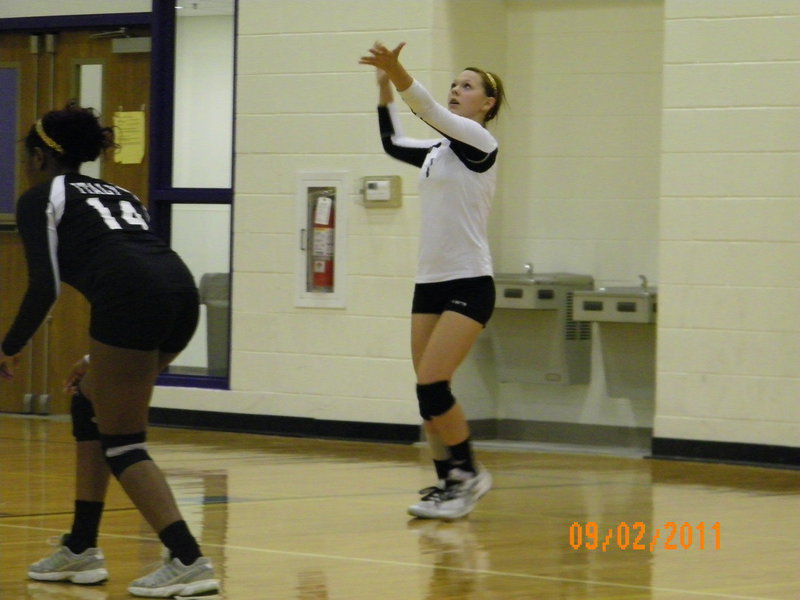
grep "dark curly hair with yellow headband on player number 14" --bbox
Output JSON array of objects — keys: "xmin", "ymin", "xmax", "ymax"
[{"xmin": 25, "ymin": 102, "xmax": 116, "ymax": 169}]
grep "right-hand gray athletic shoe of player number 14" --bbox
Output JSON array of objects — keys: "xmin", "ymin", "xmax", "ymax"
[{"xmin": 128, "ymin": 556, "xmax": 219, "ymax": 598}]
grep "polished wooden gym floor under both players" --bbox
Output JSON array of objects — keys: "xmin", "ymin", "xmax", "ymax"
[{"xmin": 0, "ymin": 415, "xmax": 800, "ymax": 600}]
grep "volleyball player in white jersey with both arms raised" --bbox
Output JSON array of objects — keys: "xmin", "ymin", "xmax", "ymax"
[{"xmin": 359, "ymin": 42, "xmax": 504, "ymax": 519}]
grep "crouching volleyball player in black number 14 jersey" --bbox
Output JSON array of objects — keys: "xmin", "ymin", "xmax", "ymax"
[{"xmin": 0, "ymin": 104, "xmax": 219, "ymax": 598}]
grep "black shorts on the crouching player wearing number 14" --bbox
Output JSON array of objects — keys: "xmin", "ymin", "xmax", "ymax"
[{"xmin": 89, "ymin": 289, "xmax": 200, "ymax": 353}]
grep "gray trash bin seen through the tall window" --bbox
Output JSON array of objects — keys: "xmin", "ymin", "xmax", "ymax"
[{"xmin": 199, "ymin": 273, "xmax": 231, "ymax": 376}]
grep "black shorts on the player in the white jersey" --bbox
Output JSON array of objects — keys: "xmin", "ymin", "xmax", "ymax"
[{"xmin": 411, "ymin": 275, "xmax": 495, "ymax": 326}]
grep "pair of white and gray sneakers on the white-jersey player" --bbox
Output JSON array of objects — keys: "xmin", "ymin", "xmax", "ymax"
[{"xmin": 408, "ymin": 469, "xmax": 492, "ymax": 521}]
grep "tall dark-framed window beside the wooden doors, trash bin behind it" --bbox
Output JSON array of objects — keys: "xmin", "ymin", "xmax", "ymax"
[{"xmin": 151, "ymin": 0, "xmax": 236, "ymax": 387}]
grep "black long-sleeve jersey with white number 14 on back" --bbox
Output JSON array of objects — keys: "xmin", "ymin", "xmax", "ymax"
[{"xmin": 2, "ymin": 173, "xmax": 194, "ymax": 356}]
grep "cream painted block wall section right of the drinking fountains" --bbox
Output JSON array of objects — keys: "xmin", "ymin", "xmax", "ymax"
[{"xmin": 655, "ymin": 0, "xmax": 800, "ymax": 446}]
